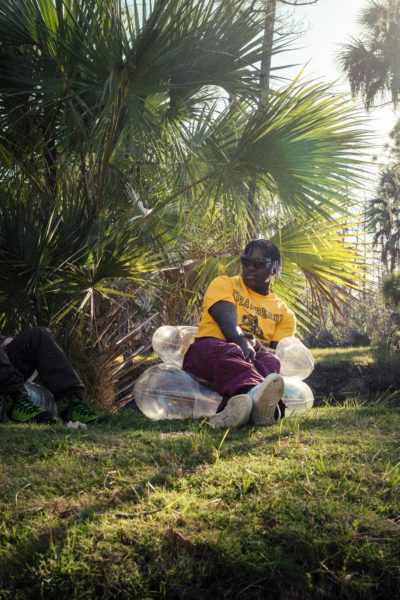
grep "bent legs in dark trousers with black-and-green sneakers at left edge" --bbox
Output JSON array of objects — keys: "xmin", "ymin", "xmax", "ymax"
[{"xmin": 0, "ymin": 327, "xmax": 98, "ymax": 423}]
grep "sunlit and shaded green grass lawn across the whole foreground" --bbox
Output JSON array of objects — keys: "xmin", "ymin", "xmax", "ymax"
[{"xmin": 0, "ymin": 401, "xmax": 400, "ymax": 600}]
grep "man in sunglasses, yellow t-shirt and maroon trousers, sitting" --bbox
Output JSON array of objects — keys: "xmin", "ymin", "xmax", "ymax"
[{"xmin": 183, "ymin": 239, "xmax": 296, "ymax": 427}]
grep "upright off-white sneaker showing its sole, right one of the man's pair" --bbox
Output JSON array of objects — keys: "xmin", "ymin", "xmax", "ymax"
[{"xmin": 247, "ymin": 373, "xmax": 283, "ymax": 427}]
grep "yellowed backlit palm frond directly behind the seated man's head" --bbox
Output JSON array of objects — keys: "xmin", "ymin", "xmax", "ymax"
[{"xmin": 178, "ymin": 219, "xmax": 372, "ymax": 329}]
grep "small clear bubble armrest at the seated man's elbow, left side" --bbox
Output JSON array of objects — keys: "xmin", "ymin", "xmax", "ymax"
[{"xmin": 151, "ymin": 325, "xmax": 197, "ymax": 367}]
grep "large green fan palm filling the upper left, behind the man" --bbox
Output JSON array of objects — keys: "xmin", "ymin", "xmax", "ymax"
[{"xmin": 0, "ymin": 0, "xmax": 366, "ymax": 340}]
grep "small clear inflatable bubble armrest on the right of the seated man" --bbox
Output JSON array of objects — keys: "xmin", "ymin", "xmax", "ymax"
[{"xmin": 276, "ymin": 336, "xmax": 314, "ymax": 379}]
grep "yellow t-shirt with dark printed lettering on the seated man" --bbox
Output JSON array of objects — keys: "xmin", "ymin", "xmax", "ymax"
[{"xmin": 197, "ymin": 275, "xmax": 296, "ymax": 345}]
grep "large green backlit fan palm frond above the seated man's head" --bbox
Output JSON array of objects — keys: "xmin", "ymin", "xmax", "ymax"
[{"xmin": 148, "ymin": 78, "xmax": 371, "ymax": 230}]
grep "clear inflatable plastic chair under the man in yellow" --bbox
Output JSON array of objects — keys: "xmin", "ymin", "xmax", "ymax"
[{"xmin": 134, "ymin": 325, "xmax": 314, "ymax": 421}]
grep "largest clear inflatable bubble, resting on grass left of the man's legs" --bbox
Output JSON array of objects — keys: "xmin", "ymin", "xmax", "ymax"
[{"xmin": 134, "ymin": 363, "xmax": 221, "ymax": 421}]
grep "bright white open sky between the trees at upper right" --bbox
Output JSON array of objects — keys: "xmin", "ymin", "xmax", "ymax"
[{"xmin": 279, "ymin": 0, "xmax": 400, "ymax": 163}]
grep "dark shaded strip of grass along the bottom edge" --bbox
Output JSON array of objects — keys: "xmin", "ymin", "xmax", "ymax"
[{"xmin": 0, "ymin": 506, "xmax": 399, "ymax": 600}]
